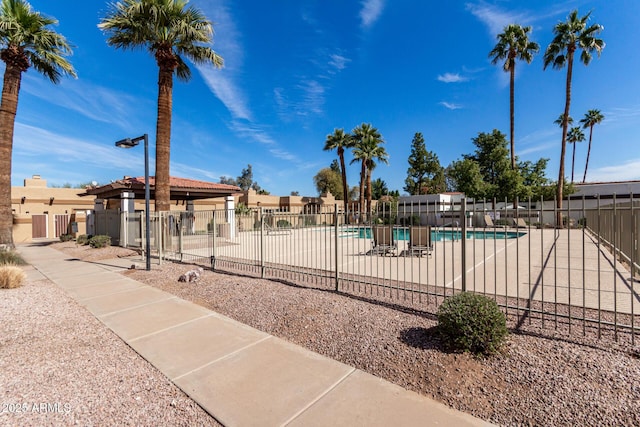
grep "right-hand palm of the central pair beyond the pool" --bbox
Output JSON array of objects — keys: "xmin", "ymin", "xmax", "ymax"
[{"xmin": 351, "ymin": 123, "xmax": 389, "ymax": 222}]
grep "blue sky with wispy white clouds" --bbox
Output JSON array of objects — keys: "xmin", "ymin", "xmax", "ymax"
[{"xmin": 12, "ymin": 0, "xmax": 640, "ymax": 195}]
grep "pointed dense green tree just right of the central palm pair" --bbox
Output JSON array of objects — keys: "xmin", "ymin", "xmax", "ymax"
[{"xmin": 404, "ymin": 132, "xmax": 446, "ymax": 195}]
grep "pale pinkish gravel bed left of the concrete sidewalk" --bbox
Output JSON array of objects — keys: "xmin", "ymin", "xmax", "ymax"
[{"xmin": 0, "ymin": 266, "xmax": 220, "ymax": 426}]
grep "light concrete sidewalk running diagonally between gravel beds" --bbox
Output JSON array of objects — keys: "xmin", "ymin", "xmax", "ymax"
[{"xmin": 18, "ymin": 244, "xmax": 489, "ymax": 426}]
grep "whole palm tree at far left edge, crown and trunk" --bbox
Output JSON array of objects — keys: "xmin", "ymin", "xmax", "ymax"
[{"xmin": 0, "ymin": 0, "xmax": 76, "ymax": 248}]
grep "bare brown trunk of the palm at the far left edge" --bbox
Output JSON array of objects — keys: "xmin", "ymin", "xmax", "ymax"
[{"xmin": 0, "ymin": 63, "xmax": 22, "ymax": 248}]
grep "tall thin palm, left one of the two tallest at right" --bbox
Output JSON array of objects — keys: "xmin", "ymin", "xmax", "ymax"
[{"xmin": 489, "ymin": 24, "xmax": 540, "ymax": 170}]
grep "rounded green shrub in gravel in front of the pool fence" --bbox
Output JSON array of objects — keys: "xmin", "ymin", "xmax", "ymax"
[{"xmin": 438, "ymin": 292, "xmax": 507, "ymax": 355}]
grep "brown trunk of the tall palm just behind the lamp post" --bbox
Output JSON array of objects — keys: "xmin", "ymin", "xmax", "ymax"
[{"xmin": 155, "ymin": 67, "xmax": 173, "ymax": 211}]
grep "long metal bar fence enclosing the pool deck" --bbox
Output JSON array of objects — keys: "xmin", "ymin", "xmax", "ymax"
[{"xmin": 126, "ymin": 197, "xmax": 640, "ymax": 343}]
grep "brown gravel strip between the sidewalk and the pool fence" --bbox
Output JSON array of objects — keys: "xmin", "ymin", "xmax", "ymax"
[{"xmin": 30, "ymin": 242, "xmax": 640, "ymax": 426}]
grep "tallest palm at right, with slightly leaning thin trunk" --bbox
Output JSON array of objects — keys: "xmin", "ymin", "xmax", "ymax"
[{"xmin": 543, "ymin": 10, "xmax": 605, "ymax": 227}]
